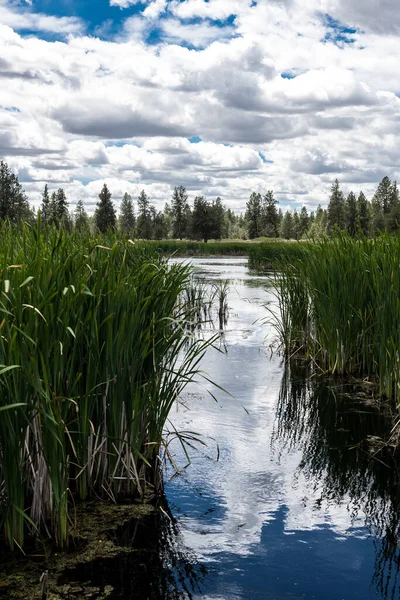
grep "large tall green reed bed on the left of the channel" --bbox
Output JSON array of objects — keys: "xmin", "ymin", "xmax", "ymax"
[{"xmin": 0, "ymin": 226, "xmax": 211, "ymax": 549}]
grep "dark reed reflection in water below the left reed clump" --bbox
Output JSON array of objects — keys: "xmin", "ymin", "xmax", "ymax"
[{"xmin": 58, "ymin": 499, "xmax": 206, "ymax": 600}]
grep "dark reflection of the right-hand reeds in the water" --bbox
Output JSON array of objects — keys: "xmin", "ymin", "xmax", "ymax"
[{"xmin": 272, "ymin": 364, "xmax": 400, "ymax": 600}]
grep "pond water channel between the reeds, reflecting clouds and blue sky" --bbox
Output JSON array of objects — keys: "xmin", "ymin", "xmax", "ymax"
[{"xmin": 165, "ymin": 258, "xmax": 400, "ymax": 600}]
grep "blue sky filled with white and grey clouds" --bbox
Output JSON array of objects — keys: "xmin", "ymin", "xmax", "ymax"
[{"xmin": 0, "ymin": 0, "xmax": 400, "ymax": 213}]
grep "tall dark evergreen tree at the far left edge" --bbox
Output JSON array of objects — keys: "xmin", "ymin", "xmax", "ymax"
[{"xmin": 0, "ymin": 161, "xmax": 32, "ymax": 223}]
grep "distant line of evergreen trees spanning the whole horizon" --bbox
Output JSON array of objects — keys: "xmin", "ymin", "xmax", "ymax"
[{"xmin": 0, "ymin": 161, "xmax": 400, "ymax": 242}]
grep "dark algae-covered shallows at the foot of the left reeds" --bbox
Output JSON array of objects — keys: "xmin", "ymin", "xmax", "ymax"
[{"xmin": 0, "ymin": 502, "xmax": 201, "ymax": 600}]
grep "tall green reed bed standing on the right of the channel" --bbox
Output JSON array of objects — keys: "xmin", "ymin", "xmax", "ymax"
[{"xmin": 274, "ymin": 235, "xmax": 400, "ymax": 401}]
